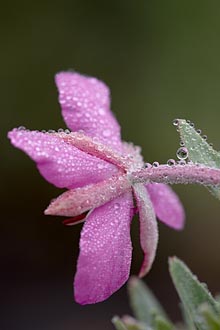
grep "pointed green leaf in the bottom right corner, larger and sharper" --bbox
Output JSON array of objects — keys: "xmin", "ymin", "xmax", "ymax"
[{"xmin": 169, "ymin": 257, "xmax": 218, "ymax": 330}]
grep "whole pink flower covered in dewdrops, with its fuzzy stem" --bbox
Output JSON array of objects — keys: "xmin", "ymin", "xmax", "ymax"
[{"xmin": 9, "ymin": 72, "xmax": 220, "ymax": 304}]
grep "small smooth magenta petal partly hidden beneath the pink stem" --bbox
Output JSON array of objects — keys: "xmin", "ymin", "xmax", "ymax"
[{"xmin": 146, "ymin": 183, "xmax": 185, "ymax": 229}]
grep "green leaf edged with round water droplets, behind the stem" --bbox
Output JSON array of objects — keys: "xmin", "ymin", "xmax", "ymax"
[{"xmin": 175, "ymin": 119, "xmax": 220, "ymax": 199}]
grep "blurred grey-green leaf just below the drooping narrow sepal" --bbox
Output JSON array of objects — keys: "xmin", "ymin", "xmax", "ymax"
[{"xmin": 128, "ymin": 277, "xmax": 167, "ymax": 326}]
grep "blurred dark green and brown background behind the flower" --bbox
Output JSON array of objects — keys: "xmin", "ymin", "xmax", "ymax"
[{"xmin": 0, "ymin": 0, "xmax": 220, "ymax": 330}]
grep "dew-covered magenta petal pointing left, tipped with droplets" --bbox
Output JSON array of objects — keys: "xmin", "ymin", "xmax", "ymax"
[{"xmin": 8, "ymin": 129, "xmax": 118, "ymax": 188}]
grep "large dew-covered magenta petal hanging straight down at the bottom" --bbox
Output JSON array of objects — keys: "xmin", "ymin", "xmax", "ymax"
[{"xmin": 74, "ymin": 193, "xmax": 133, "ymax": 305}]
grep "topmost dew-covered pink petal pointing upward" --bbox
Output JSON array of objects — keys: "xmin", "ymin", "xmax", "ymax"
[{"xmin": 55, "ymin": 72, "xmax": 122, "ymax": 151}]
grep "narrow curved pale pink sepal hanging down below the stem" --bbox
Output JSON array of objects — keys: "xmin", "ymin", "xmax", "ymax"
[{"xmin": 133, "ymin": 183, "xmax": 158, "ymax": 277}]
